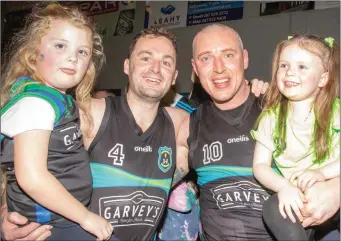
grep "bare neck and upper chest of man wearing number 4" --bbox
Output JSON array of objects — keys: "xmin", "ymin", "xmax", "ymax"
[{"xmin": 127, "ymin": 91, "xmax": 160, "ymax": 132}]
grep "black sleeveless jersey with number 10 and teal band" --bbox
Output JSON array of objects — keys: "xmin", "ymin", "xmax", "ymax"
[{"xmin": 188, "ymin": 94, "xmax": 270, "ymax": 240}]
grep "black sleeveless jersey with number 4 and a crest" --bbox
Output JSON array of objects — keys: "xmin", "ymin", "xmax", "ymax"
[{"xmin": 89, "ymin": 96, "xmax": 176, "ymax": 240}]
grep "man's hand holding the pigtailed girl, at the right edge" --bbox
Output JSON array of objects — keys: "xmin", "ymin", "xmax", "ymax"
[{"xmin": 302, "ymin": 177, "xmax": 340, "ymax": 227}]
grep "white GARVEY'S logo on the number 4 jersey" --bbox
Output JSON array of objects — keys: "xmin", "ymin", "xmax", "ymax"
[{"xmin": 99, "ymin": 191, "xmax": 164, "ymax": 227}]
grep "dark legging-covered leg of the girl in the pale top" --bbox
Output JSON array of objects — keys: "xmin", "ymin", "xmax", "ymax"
[{"xmin": 263, "ymin": 194, "xmax": 314, "ymax": 241}]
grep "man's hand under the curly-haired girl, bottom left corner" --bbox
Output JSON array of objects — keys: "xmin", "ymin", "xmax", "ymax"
[{"xmin": 0, "ymin": 207, "xmax": 52, "ymax": 240}]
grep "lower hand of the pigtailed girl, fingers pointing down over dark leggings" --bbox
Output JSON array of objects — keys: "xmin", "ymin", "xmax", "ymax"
[{"xmin": 278, "ymin": 182, "xmax": 306, "ymax": 223}]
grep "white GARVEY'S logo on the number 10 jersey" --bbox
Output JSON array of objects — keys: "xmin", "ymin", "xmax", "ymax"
[{"xmin": 211, "ymin": 181, "xmax": 270, "ymax": 210}]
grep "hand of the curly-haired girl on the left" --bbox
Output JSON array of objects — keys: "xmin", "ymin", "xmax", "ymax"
[{"xmin": 80, "ymin": 211, "xmax": 114, "ymax": 240}]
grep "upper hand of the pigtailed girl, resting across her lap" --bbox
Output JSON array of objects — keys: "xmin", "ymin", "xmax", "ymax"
[{"xmin": 290, "ymin": 169, "xmax": 325, "ymax": 192}]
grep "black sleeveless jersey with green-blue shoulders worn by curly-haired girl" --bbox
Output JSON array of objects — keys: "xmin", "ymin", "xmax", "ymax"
[{"xmin": 1, "ymin": 80, "xmax": 92, "ymax": 225}]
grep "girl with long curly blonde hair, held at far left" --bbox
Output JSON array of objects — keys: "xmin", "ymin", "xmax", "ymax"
[{"xmin": 1, "ymin": 3, "xmax": 113, "ymax": 240}]
